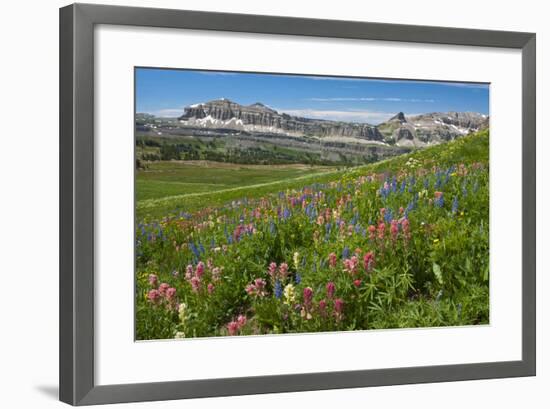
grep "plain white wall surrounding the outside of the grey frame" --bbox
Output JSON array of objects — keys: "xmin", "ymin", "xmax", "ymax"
[{"xmin": 0, "ymin": 0, "xmax": 550, "ymax": 409}]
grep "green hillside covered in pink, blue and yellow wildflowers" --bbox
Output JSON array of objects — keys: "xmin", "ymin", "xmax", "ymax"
[{"xmin": 136, "ymin": 131, "xmax": 489, "ymax": 339}]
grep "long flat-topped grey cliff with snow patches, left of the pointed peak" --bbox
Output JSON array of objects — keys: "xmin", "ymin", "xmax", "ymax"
[{"xmin": 179, "ymin": 99, "xmax": 383, "ymax": 141}]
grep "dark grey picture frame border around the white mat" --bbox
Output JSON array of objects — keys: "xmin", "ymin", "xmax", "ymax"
[{"xmin": 59, "ymin": 4, "xmax": 536, "ymax": 405}]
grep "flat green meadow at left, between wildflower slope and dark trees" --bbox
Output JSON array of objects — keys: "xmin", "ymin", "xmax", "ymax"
[{"xmin": 136, "ymin": 161, "xmax": 342, "ymax": 220}]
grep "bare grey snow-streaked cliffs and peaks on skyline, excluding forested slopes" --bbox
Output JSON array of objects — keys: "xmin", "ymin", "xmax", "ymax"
[{"xmin": 178, "ymin": 98, "xmax": 489, "ymax": 147}]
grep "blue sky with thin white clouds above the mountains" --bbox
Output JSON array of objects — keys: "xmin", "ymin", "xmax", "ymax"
[{"xmin": 136, "ymin": 68, "xmax": 489, "ymax": 124}]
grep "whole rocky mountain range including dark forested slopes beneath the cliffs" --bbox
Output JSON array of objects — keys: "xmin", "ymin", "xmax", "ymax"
[{"xmin": 135, "ymin": 98, "xmax": 489, "ymax": 165}]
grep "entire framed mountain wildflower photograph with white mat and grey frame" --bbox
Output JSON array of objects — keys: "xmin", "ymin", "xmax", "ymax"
[{"xmin": 60, "ymin": 4, "xmax": 536, "ymax": 405}]
